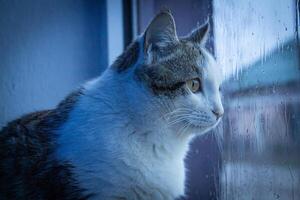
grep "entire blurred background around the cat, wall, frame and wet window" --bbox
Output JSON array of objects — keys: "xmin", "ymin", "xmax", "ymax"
[{"xmin": 0, "ymin": 0, "xmax": 300, "ymax": 200}]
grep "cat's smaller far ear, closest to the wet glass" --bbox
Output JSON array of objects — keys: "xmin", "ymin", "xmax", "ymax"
[{"xmin": 187, "ymin": 20, "xmax": 210, "ymax": 46}]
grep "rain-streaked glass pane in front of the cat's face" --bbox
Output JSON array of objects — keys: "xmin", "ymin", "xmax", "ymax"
[{"xmin": 214, "ymin": 0, "xmax": 300, "ymax": 200}]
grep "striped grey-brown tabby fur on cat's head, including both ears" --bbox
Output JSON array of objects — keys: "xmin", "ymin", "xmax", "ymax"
[{"xmin": 112, "ymin": 11, "xmax": 209, "ymax": 97}]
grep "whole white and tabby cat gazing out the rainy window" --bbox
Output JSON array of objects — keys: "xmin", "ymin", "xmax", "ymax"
[{"xmin": 0, "ymin": 11, "xmax": 224, "ymax": 200}]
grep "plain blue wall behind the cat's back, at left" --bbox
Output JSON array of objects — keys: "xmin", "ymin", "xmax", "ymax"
[{"xmin": 0, "ymin": 0, "xmax": 108, "ymax": 127}]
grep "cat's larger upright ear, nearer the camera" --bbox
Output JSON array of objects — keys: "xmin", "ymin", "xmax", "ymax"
[{"xmin": 144, "ymin": 10, "xmax": 178, "ymax": 52}]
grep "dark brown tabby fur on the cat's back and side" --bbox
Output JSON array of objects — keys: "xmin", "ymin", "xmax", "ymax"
[{"xmin": 0, "ymin": 90, "xmax": 86, "ymax": 200}]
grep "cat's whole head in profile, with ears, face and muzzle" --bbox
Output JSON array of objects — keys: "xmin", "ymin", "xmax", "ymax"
[{"xmin": 111, "ymin": 11, "xmax": 224, "ymax": 136}]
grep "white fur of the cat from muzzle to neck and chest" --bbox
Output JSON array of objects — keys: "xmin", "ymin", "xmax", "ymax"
[{"xmin": 57, "ymin": 39, "xmax": 223, "ymax": 200}]
